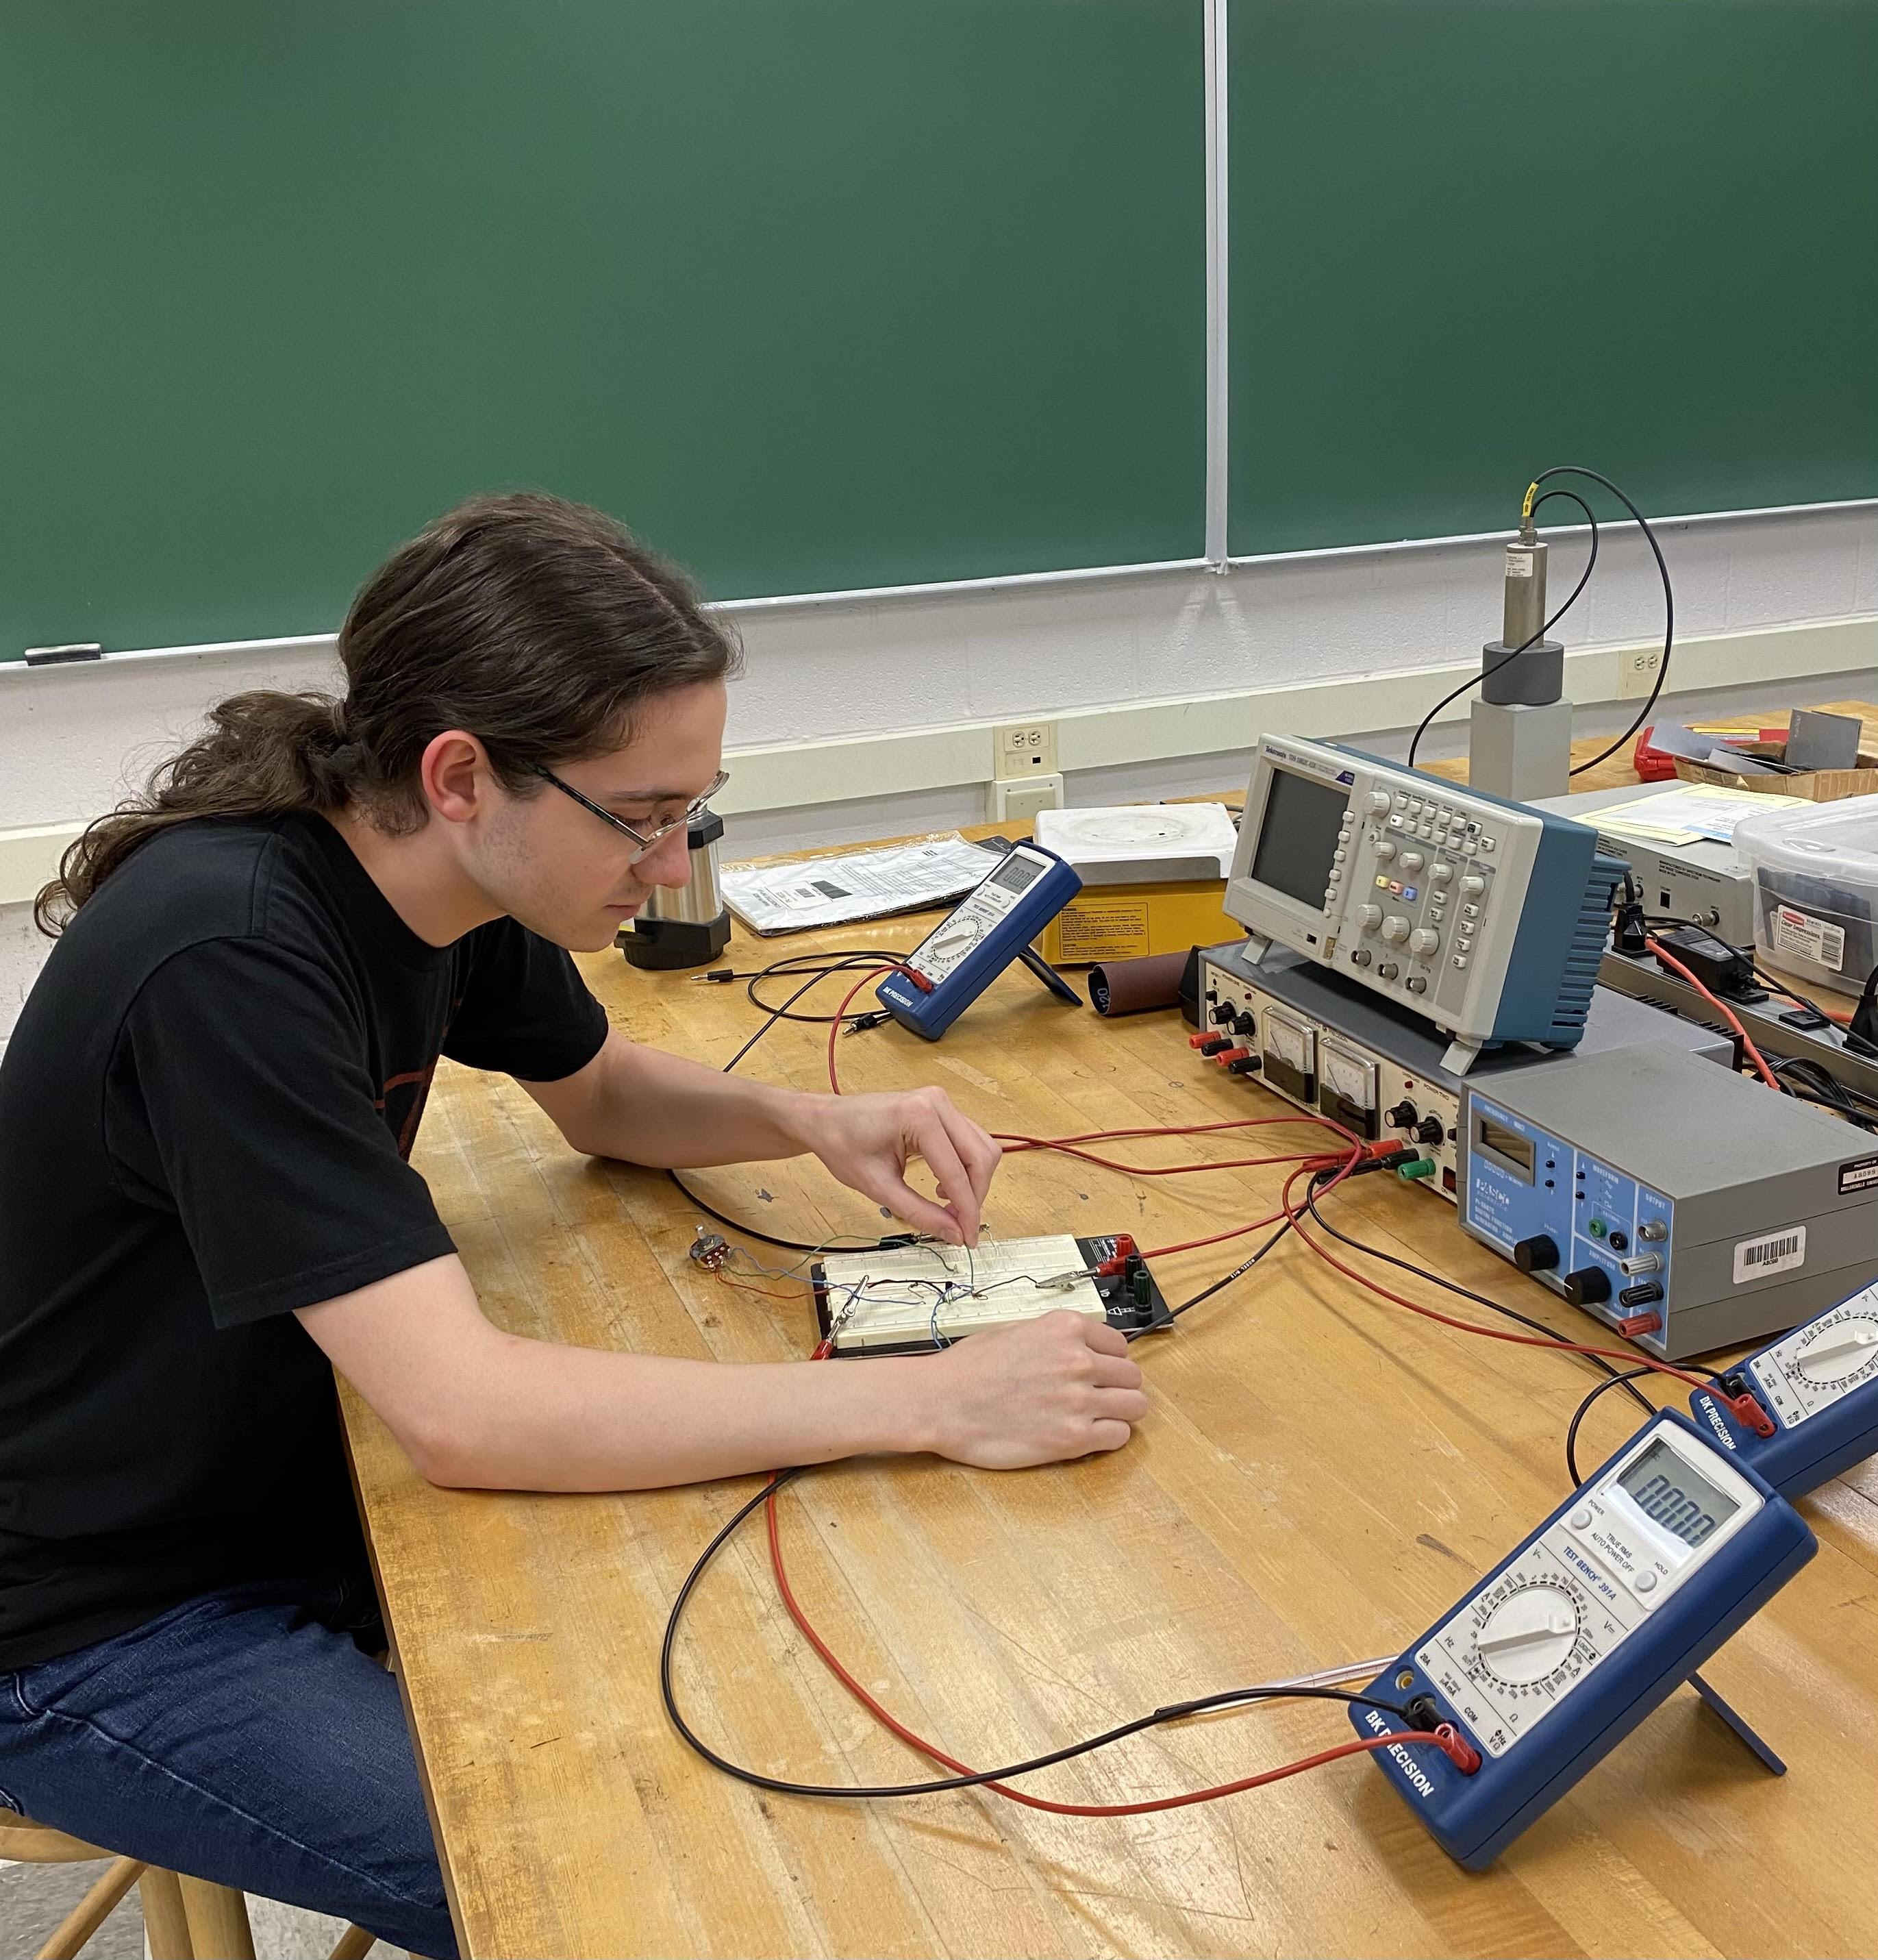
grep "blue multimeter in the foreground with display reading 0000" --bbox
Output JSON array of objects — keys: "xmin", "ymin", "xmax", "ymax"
[{"xmin": 1351, "ymin": 1411, "xmax": 1819, "ymax": 1872}]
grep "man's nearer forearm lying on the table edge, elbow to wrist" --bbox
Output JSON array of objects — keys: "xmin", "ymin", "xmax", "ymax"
[{"xmin": 414, "ymin": 1329, "xmax": 935, "ymax": 1489}]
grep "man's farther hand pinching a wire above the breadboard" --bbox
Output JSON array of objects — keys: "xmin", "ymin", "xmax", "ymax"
[{"xmin": 802, "ymin": 1088, "xmax": 1003, "ymax": 1245}]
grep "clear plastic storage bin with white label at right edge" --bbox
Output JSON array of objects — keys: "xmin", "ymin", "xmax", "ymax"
[{"xmin": 1735, "ymin": 796, "xmax": 1878, "ymax": 994}]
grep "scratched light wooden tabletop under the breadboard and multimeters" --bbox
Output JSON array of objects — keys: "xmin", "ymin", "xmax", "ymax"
[{"xmin": 343, "ymin": 721, "xmax": 1878, "ymax": 1956}]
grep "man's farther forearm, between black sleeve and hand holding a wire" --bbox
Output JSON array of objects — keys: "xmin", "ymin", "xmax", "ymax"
[{"xmin": 568, "ymin": 1045, "xmax": 818, "ymax": 1170}]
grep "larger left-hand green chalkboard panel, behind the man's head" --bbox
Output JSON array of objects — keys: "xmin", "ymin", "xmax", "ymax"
[{"xmin": 0, "ymin": 0, "xmax": 1205, "ymax": 656}]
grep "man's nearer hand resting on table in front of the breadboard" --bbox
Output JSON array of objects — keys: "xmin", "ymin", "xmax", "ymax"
[{"xmin": 921, "ymin": 1307, "xmax": 1147, "ymax": 1470}]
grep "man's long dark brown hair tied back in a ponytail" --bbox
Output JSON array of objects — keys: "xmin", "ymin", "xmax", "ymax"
[{"xmin": 34, "ymin": 496, "xmax": 737, "ymax": 935}]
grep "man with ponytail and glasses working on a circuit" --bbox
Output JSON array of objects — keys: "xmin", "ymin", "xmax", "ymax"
[{"xmin": 0, "ymin": 496, "xmax": 1145, "ymax": 1956}]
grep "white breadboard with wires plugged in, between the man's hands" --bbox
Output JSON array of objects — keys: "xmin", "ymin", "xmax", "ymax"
[{"xmin": 816, "ymin": 1233, "xmax": 1107, "ymax": 1354}]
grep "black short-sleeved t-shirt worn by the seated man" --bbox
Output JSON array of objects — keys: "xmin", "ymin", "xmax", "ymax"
[{"xmin": 0, "ymin": 815, "xmax": 605, "ymax": 1670}]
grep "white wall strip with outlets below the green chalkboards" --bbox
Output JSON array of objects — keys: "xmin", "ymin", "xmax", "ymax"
[{"xmin": 0, "ymin": 506, "xmax": 1878, "ymax": 1035}]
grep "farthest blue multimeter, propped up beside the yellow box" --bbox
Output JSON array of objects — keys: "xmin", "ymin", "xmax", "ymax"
[{"xmin": 875, "ymin": 845, "xmax": 1082, "ymax": 1041}]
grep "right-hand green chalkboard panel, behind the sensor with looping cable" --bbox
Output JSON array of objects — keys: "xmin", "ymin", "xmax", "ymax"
[{"xmin": 1229, "ymin": 0, "xmax": 1878, "ymax": 553}]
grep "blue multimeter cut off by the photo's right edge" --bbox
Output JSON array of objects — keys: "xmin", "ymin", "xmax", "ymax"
[{"xmin": 1690, "ymin": 1282, "xmax": 1878, "ymax": 1498}]
